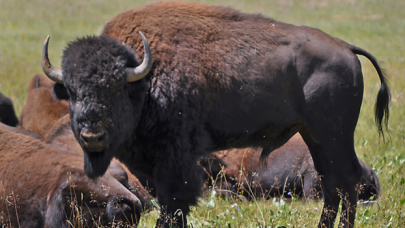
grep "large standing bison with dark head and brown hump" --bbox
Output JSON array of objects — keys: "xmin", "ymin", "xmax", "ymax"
[{"xmin": 42, "ymin": 2, "xmax": 389, "ymax": 227}]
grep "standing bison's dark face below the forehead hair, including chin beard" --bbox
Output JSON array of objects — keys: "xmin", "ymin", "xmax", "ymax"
[{"xmin": 65, "ymin": 82, "xmax": 140, "ymax": 177}]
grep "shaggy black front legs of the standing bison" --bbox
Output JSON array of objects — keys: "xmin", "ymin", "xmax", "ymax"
[{"xmin": 153, "ymin": 155, "xmax": 203, "ymax": 227}]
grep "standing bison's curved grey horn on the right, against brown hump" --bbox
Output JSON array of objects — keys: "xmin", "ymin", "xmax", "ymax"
[{"xmin": 126, "ymin": 32, "xmax": 152, "ymax": 82}]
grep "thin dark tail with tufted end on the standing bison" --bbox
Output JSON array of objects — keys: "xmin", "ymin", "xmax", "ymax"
[{"xmin": 349, "ymin": 45, "xmax": 391, "ymax": 139}]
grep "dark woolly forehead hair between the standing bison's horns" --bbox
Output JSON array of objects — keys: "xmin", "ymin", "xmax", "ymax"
[{"xmin": 62, "ymin": 36, "xmax": 139, "ymax": 93}]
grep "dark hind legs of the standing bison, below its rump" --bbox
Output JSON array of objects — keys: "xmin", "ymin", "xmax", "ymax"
[{"xmin": 301, "ymin": 128, "xmax": 362, "ymax": 227}]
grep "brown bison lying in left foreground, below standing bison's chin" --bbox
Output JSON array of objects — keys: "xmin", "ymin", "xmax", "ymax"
[{"xmin": 0, "ymin": 128, "xmax": 142, "ymax": 227}]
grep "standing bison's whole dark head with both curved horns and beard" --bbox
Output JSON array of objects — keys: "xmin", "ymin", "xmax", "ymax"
[{"xmin": 41, "ymin": 32, "xmax": 152, "ymax": 178}]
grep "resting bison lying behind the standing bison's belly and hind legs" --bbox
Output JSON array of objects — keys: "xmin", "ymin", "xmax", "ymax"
[{"xmin": 200, "ymin": 134, "xmax": 380, "ymax": 200}]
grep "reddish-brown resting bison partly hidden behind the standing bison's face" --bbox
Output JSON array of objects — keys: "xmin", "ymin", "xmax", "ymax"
[{"xmin": 20, "ymin": 75, "xmax": 156, "ymax": 208}]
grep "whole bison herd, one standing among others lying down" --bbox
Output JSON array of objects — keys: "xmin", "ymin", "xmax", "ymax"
[{"xmin": 0, "ymin": 2, "xmax": 390, "ymax": 227}]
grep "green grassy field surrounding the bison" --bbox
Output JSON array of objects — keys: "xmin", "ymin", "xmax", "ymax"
[{"xmin": 0, "ymin": 0, "xmax": 405, "ymax": 227}]
